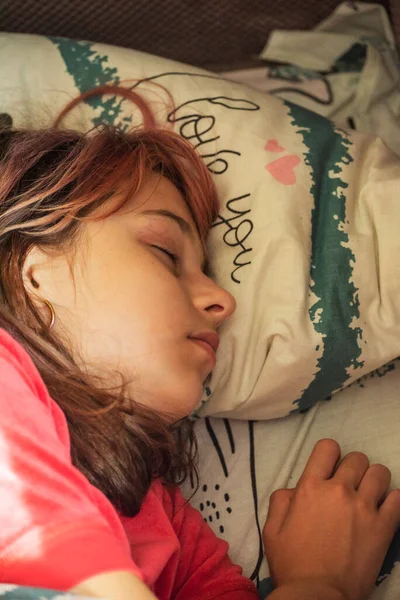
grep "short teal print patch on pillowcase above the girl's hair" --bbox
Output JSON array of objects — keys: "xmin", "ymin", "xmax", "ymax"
[{"xmin": 48, "ymin": 37, "xmax": 131, "ymax": 131}]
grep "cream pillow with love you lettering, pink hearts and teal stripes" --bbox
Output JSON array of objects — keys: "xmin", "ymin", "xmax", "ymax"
[{"xmin": 0, "ymin": 34, "xmax": 400, "ymax": 419}]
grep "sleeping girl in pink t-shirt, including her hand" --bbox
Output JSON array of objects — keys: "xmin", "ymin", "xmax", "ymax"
[{"xmin": 0, "ymin": 88, "xmax": 400, "ymax": 600}]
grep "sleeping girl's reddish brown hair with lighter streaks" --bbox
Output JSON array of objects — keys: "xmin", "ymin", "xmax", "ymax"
[{"xmin": 0, "ymin": 89, "xmax": 218, "ymax": 516}]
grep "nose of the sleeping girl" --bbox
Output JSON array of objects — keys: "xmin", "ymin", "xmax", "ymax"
[{"xmin": 193, "ymin": 275, "xmax": 236, "ymax": 328}]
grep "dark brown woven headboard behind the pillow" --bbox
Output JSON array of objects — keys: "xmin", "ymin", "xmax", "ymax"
[{"xmin": 0, "ymin": 0, "xmax": 400, "ymax": 70}]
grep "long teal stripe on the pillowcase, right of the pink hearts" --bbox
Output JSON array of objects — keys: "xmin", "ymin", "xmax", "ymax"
[{"xmin": 285, "ymin": 102, "xmax": 364, "ymax": 412}]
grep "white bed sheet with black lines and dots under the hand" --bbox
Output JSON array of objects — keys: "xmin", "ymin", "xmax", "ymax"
[{"xmin": 183, "ymin": 359, "xmax": 400, "ymax": 600}]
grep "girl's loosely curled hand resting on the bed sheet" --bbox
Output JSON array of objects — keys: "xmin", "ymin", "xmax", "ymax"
[{"xmin": 263, "ymin": 439, "xmax": 400, "ymax": 600}]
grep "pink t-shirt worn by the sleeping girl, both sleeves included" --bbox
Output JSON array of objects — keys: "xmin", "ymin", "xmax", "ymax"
[{"xmin": 0, "ymin": 330, "xmax": 258, "ymax": 600}]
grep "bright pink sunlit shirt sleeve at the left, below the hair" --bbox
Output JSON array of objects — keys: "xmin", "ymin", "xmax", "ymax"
[{"xmin": 0, "ymin": 332, "xmax": 141, "ymax": 591}]
